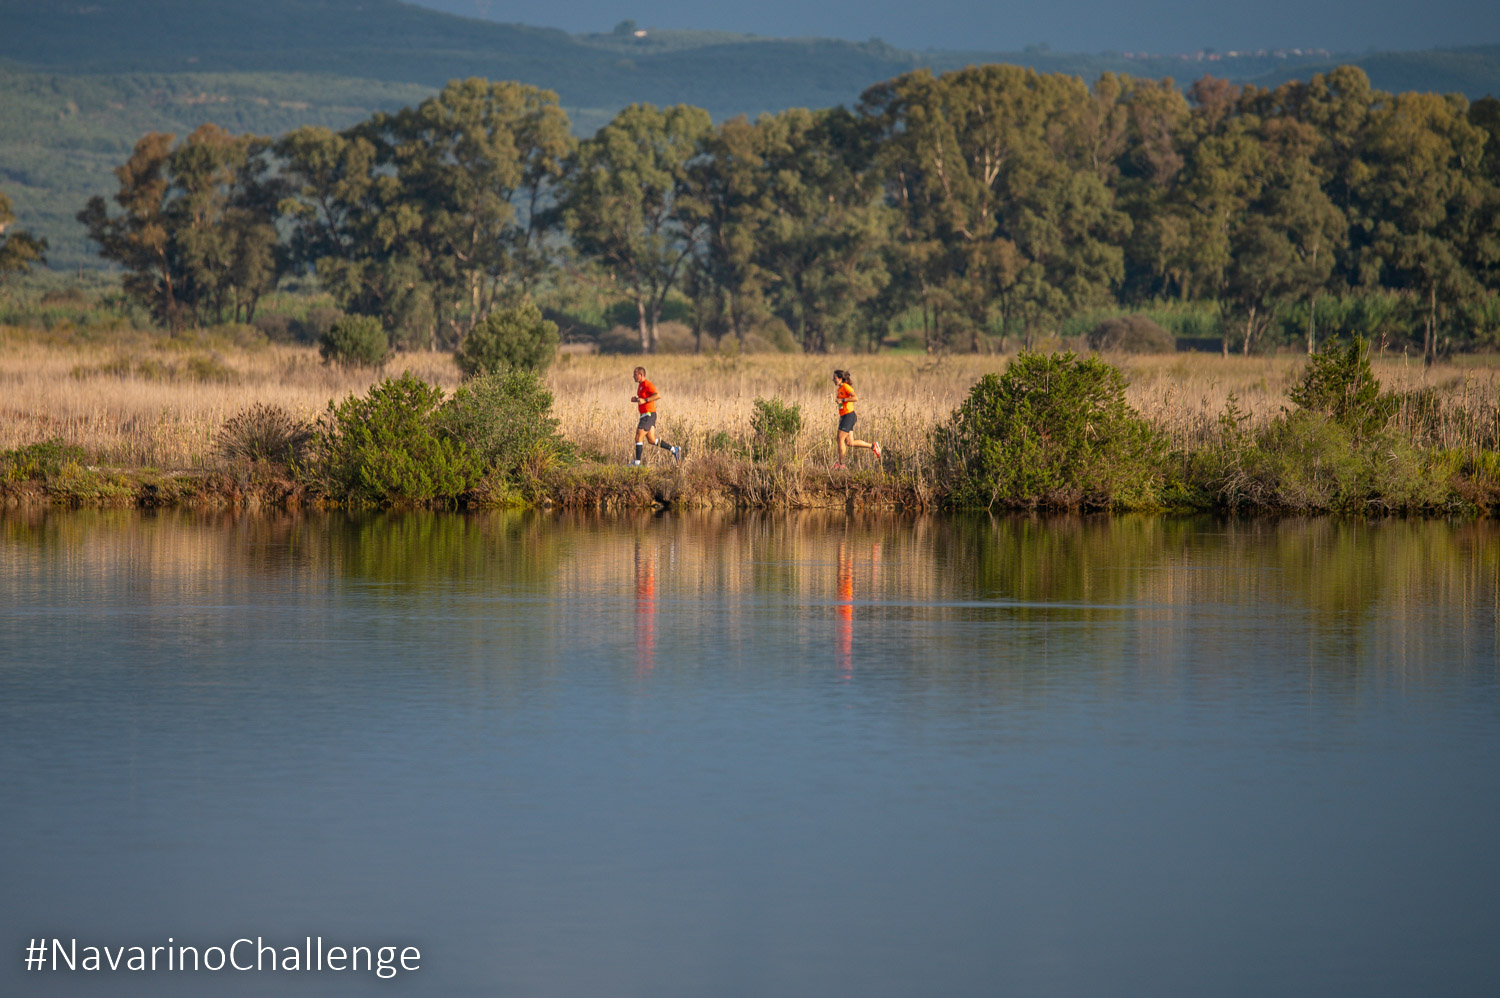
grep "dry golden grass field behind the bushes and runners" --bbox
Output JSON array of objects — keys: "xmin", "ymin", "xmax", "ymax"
[{"xmin": 0, "ymin": 329, "xmax": 1500, "ymax": 468}]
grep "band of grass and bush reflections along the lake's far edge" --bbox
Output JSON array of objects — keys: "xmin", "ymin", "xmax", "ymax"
[{"xmin": 0, "ymin": 510, "xmax": 1500, "ymax": 686}]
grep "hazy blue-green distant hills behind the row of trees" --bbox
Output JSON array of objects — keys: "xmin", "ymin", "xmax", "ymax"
[{"xmin": 0, "ymin": 0, "xmax": 1500, "ymax": 267}]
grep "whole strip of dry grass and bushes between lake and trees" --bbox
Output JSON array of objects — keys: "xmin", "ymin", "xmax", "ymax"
[{"xmin": 0, "ymin": 322, "xmax": 1500, "ymax": 515}]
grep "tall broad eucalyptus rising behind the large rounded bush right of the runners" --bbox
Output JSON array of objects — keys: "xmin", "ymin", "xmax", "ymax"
[{"xmin": 861, "ymin": 66, "xmax": 1131, "ymax": 347}]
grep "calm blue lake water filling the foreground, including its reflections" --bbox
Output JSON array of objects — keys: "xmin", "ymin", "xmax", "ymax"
[{"xmin": 0, "ymin": 512, "xmax": 1500, "ymax": 998}]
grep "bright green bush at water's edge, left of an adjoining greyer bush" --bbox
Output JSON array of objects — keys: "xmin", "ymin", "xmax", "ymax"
[{"xmin": 311, "ymin": 371, "xmax": 483, "ymax": 504}]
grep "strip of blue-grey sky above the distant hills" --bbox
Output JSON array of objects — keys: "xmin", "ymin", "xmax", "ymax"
[{"xmin": 410, "ymin": 0, "xmax": 1500, "ymax": 54}]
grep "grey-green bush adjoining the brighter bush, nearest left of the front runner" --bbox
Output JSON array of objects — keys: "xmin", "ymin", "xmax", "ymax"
[{"xmin": 440, "ymin": 368, "xmax": 572, "ymax": 476}]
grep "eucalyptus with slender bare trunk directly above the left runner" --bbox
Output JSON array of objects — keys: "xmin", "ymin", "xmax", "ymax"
[{"xmin": 558, "ymin": 104, "xmax": 713, "ymax": 353}]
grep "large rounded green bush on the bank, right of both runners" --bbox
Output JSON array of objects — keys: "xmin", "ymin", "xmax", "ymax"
[{"xmin": 933, "ymin": 353, "xmax": 1163, "ymax": 509}]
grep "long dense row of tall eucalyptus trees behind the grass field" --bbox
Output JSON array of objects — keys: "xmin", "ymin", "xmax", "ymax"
[{"xmin": 67, "ymin": 66, "xmax": 1500, "ymax": 360}]
